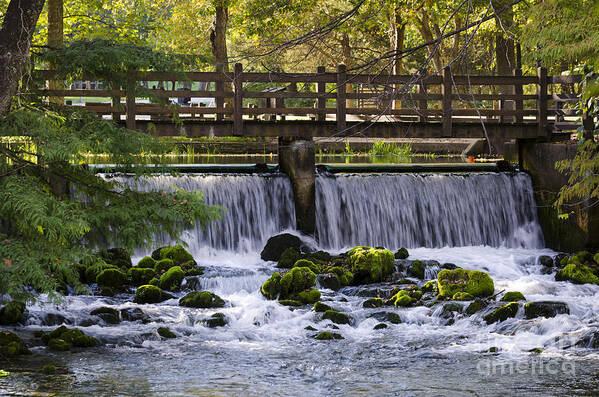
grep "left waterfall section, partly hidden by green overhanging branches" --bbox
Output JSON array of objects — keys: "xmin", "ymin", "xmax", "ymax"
[{"xmin": 111, "ymin": 174, "xmax": 295, "ymax": 252}]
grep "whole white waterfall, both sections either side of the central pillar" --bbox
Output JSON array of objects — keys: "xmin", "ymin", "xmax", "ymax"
[{"xmin": 111, "ymin": 173, "xmax": 543, "ymax": 253}]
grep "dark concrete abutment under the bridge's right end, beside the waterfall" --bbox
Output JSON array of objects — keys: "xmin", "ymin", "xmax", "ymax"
[{"xmin": 505, "ymin": 140, "xmax": 599, "ymax": 252}]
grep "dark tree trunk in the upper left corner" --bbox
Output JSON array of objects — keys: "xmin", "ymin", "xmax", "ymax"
[{"xmin": 0, "ymin": 0, "xmax": 44, "ymax": 115}]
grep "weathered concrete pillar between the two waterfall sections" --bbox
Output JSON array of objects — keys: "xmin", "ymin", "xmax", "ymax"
[{"xmin": 279, "ymin": 137, "xmax": 316, "ymax": 235}]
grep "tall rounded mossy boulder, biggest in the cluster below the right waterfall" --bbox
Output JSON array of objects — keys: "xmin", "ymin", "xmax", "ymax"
[{"xmin": 347, "ymin": 246, "xmax": 395, "ymax": 284}]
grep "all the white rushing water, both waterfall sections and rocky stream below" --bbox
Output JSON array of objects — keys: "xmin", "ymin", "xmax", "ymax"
[{"xmin": 0, "ymin": 174, "xmax": 599, "ymax": 396}]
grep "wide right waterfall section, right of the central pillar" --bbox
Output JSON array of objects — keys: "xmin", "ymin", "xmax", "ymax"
[{"xmin": 316, "ymin": 173, "xmax": 544, "ymax": 248}]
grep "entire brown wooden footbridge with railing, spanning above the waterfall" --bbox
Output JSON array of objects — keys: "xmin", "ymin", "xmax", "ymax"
[{"xmin": 37, "ymin": 64, "xmax": 584, "ymax": 142}]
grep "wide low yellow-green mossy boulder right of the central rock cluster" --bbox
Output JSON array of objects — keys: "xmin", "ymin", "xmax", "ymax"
[{"xmin": 437, "ymin": 269, "xmax": 495, "ymax": 298}]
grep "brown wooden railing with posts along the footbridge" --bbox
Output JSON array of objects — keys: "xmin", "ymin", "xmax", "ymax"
[{"xmin": 37, "ymin": 64, "xmax": 581, "ymax": 137}]
